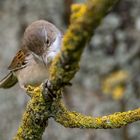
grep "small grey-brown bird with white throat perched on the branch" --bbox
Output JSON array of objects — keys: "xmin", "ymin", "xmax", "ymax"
[{"xmin": 0, "ymin": 20, "xmax": 62, "ymax": 89}]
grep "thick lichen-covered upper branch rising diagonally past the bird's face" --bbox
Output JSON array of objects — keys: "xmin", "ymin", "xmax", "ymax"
[{"xmin": 50, "ymin": 0, "xmax": 119, "ymax": 89}]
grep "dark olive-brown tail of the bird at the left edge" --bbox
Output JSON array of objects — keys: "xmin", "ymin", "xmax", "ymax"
[{"xmin": 0, "ymin": 72, "xmax": 18, "ymax": 89}]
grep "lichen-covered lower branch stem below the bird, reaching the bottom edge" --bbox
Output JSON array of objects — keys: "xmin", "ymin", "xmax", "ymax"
[{"xmin": 14, "ymin": 86, "xmax": 50, "ymax": 140}]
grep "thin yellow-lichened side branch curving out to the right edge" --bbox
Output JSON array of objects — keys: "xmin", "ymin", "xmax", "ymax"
[{"xmin": 53, "ymin": 101, "xmax": 140, "ymax": 129}]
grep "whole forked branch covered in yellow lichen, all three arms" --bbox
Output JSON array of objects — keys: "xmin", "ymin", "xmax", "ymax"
[{"xmin": 14, "ymin": 0, "xmax": 140, "ymax": 140}]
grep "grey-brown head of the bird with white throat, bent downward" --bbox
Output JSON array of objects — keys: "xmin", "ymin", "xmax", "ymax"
[{"xmin": 22, "ymin": 20, "xmax": 62, "ymax": 64}]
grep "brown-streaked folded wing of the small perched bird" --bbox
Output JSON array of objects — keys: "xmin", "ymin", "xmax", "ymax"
[{"xmin": 8, "ymin": 49, "xmax": 29, "ymax": 71}]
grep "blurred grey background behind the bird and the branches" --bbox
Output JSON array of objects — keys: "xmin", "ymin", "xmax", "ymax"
[{"xmin": 0, "ymin": 0, "xmax": 140, "ymax": 140}]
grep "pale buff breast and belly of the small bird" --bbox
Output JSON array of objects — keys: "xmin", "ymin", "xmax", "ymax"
[{"xmin": 15, "ymin": 57, "xmax": 48, "ymax": 87}]
